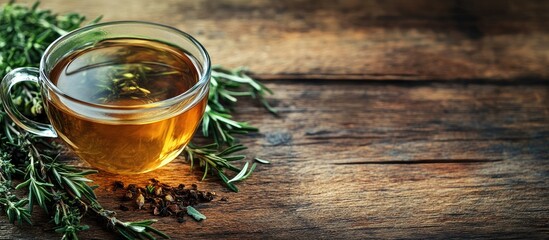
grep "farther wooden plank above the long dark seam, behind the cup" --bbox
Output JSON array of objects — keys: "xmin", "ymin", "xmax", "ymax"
[{"xmin": 6, "ymin": 0, "xmax": 549, "ymax": 81}]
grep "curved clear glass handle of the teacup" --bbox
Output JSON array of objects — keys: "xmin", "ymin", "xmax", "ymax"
[{"xmin": 0, "ymin": 67, "xmax": 57, "ymax": 137}]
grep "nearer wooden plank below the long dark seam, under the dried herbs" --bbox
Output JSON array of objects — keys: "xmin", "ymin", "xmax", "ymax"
[{"xmin": 0, "ymin": 81, "xmax": 549, "ymax": 239}]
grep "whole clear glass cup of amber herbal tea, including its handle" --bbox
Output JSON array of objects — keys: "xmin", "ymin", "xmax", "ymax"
[{"xmin": 0, "ymin": 22, "xmax": 210, "ymax": 174}]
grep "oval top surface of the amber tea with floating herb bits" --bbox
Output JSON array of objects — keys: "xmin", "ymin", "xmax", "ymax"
[{"xmin": 50, "ymin": 38, "xmax": 198, "ymax": 106}]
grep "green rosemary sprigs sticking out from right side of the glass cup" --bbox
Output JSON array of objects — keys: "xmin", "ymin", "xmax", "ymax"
[{"xmin": 185, "ymin": 65, "xmax": 277, "ymax": 192}]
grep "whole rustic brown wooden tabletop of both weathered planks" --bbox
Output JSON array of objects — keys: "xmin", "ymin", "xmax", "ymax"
[{"xmin": 0, "ymin": 0, "xmax": 549, "ymax": 239}]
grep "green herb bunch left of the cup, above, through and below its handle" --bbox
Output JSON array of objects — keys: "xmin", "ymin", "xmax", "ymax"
[{"xmin": 0, "ymin": 1, "xmax": 169, "ymax": 239}]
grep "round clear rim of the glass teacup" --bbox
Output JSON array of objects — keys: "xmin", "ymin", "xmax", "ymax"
[{"xmin": 39, "ymin": 21, "xmax": 211, "ymax": 110}]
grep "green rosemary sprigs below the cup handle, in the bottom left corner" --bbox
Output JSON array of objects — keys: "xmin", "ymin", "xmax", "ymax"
[{"xmin": 0, "ymin": 118, "xmax": 169, "ymax": 239}]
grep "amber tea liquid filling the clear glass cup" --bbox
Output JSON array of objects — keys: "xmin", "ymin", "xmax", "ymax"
[{"xmin": 46, "ymin": 38, "xmax": 207, "ymax": 174}]
